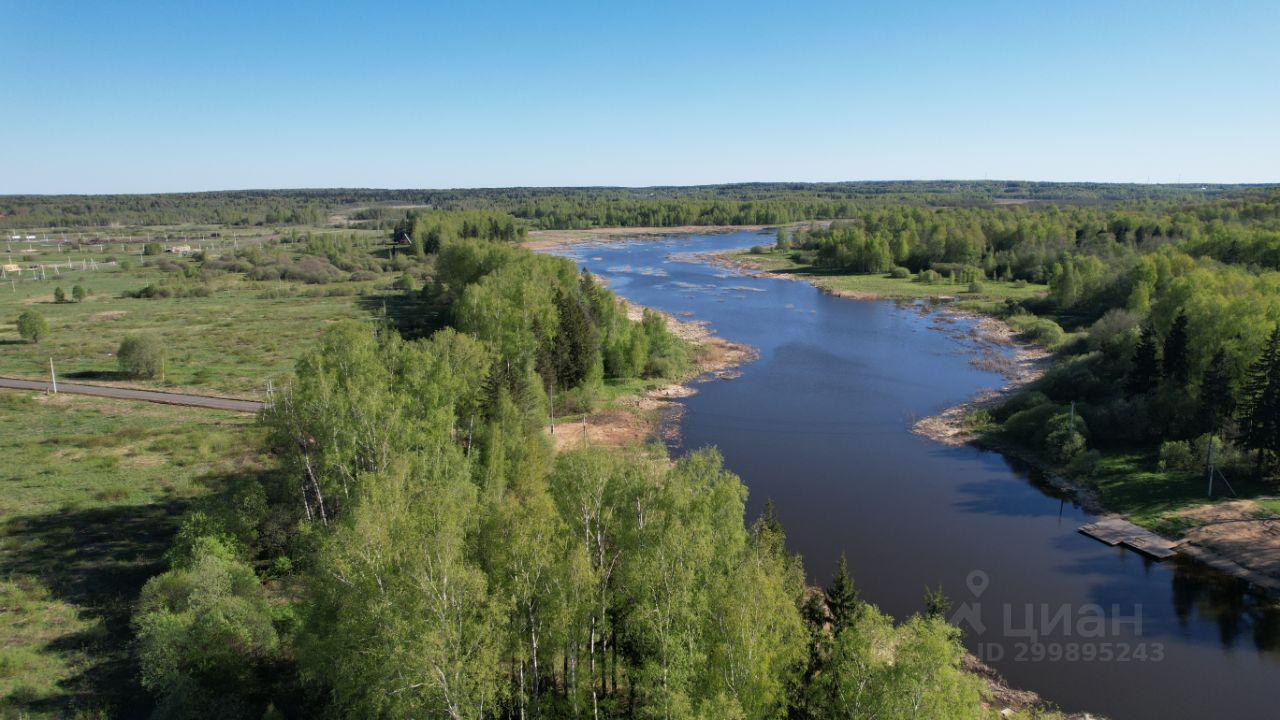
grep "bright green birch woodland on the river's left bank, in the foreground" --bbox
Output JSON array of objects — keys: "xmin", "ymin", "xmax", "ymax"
[{"xmin": 124, "ymin": 215, "xmax": 1008, "ymax": 719}]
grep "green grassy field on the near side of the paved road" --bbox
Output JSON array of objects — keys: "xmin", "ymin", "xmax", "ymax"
[{"xmin": 0, "ymin": 389, "xmax": 260, "ymax": 717}]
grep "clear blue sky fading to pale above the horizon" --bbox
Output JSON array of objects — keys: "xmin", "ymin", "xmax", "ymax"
[{"xmin": 0, "ymin": 0, "xmax": 1280, "ymax": 193}]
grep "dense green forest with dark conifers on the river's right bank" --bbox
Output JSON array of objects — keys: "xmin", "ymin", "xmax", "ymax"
[{"xmin": 780, "ymin": 195, "xmax": 1280, "ymax": 478}]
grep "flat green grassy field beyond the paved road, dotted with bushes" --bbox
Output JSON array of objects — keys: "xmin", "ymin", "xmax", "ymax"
[{"xmin": 0, "ymin": 238, "xmax": 396, "ymax": 397}]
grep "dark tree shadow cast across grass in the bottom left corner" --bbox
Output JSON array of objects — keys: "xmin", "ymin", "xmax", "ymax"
[{"xmin": 0, "ymin": 498, "xmax": 186, "ymax": 717}]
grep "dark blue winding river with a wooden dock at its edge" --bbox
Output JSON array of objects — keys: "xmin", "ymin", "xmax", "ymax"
[{"xmin": 562, "ymin": 232, "xmax": 1280, "ymax": 720}]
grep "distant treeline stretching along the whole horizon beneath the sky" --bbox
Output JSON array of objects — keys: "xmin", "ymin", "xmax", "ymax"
[{"xmin": 0, "ymin": 181, "xmax": 1280, "ymax": 229}]
